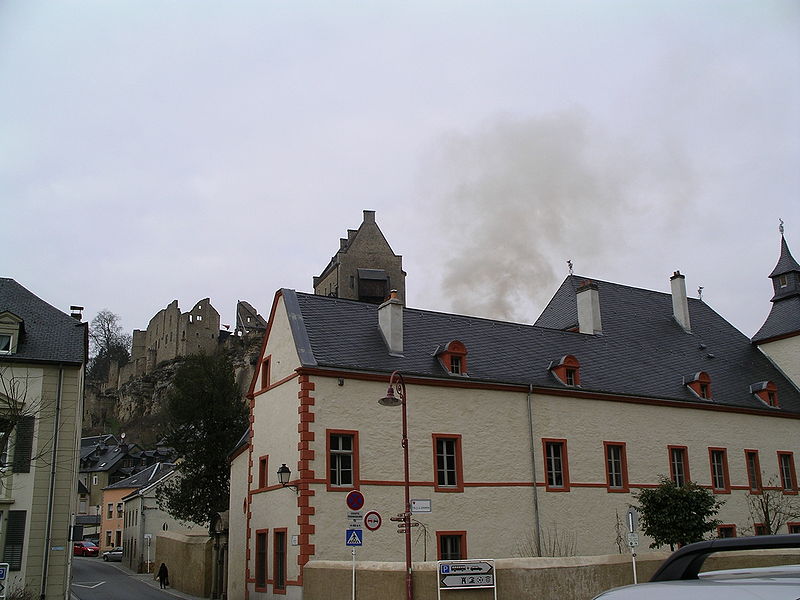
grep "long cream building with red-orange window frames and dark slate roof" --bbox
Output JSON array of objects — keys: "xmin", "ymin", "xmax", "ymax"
[{"xmin": 228, "ymin": 240, "xmax": 800, "ymax": 599}]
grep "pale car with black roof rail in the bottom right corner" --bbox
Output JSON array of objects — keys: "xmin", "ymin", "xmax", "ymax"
[{"xmin": 595, "ymin": 534, "xmax": 800, "ymax": 600}]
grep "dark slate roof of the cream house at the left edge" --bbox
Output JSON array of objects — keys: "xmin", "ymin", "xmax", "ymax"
[{"xmin": 0, "ymin": 277, "xmax": 88, "ymax": 365}]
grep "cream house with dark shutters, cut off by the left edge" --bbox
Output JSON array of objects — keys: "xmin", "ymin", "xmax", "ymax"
[{"xmin": 0, "ymin": 277, "xmax": 88, "ymax": 600}]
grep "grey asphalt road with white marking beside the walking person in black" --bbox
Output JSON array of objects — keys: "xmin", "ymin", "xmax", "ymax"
[{"xmin": 71, "ymin": 556, "xmax": 175, "ymax": 600}]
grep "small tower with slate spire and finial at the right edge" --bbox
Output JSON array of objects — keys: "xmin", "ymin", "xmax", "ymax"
[{"xmin": 752, "ymin": 221, "xmax": 800, "ymax": 387}]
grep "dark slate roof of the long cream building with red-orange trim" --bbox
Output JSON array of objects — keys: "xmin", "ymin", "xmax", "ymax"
[{"xmin": 282, "ymin": 276, "xmax": 800, "ymax": 414}]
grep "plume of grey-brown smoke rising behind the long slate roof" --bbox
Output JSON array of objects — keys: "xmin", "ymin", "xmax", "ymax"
[{"xmin": 430, "ymin": 113, "xmax": 688, "ymax": 322}]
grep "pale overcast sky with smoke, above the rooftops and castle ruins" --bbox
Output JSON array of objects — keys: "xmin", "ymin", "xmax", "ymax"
[{"xmin": 0, "ymin": 0, "xmax": 800, "ymax": 336}]
